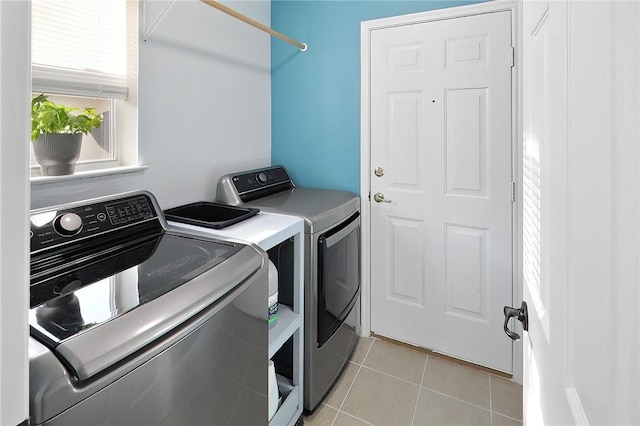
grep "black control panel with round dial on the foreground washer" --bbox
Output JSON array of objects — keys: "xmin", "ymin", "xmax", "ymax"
[{"xmin": 30, "ymin": 194, "xmax": 158, "ymax": 253}]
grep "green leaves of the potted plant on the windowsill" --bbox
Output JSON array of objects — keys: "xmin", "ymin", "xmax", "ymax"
[{"xmin": 31, "ymin": 94, "xmax": 102, "ymax": 141}]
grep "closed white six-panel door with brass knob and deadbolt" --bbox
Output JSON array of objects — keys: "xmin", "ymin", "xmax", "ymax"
[{"xmin": 370, "ymin": 11, "xmax": 513, "ymax": 372}]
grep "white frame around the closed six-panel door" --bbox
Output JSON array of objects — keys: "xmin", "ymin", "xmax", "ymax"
[{"xmin": 360, "ymin": 0, "xmax": 523, "ymax": 383}]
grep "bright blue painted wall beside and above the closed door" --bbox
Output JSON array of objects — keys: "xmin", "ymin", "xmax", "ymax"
[{"xmin": 271, "ymin": 0, "xmax": 479, "ymax": 193}]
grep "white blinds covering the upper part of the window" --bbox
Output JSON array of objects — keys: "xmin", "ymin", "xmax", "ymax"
[{"xmin": 31, "ymin": 0, "xmax": 127, "ymax": 99}]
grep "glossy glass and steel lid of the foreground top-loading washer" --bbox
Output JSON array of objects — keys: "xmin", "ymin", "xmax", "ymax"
[{"xmin": 29, "ymin": 233, "xmax": 263, "ymax": 380}]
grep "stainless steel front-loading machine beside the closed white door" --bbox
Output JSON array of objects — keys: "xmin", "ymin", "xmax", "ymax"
[{"xmin": 216, "ymin": 166, "xmax": 360, "ymax": 412}]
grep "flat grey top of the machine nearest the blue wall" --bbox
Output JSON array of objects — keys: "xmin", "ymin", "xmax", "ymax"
[{"xmin": 245, "ymin": 187, "xmax": 360, "ymax": 234}]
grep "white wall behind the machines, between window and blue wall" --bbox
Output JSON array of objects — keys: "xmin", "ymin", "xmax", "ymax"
[{"xmin": 31, "ymin": 0, "xmax": 271, "ymax": 208}]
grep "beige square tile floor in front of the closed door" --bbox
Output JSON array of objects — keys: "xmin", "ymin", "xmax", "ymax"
[{"xmin": 304, "ymin": 338, "xmax": 522, "ymax": 426}]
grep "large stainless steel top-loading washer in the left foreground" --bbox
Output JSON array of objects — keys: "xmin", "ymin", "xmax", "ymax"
[{"xmin": 29, "ymin": 191, "xmax": 268, "ymax": 425}]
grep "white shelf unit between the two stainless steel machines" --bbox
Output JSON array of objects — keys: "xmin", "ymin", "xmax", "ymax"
[{"xmin": 169, "ymin": 212, "xmax": 304, "ymax": 426}]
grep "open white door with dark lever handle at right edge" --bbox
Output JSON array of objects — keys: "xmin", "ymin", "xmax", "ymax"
[{"xmin": 523, "ymin": 0, "xmax": 640, "ymax": 425}]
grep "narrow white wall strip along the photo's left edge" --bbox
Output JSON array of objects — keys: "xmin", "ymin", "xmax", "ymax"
[{"xmin": 0, "ymin": 1, "xmax": 31, "ymax": 425}]
